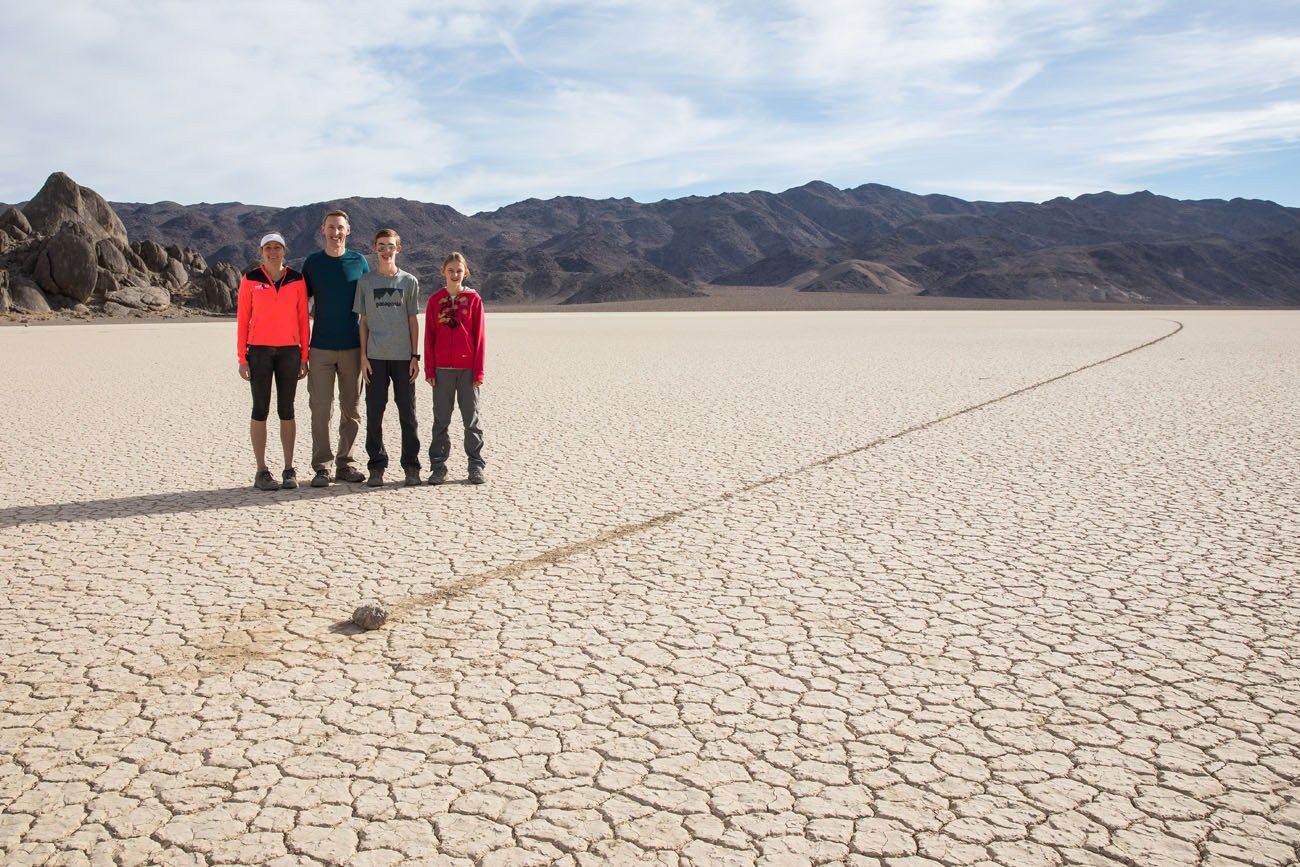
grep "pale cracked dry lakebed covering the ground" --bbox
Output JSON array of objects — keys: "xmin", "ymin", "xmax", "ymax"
[{"xmin": 0, "ymin": 311, "xmax": 1300, "ymax": 867}]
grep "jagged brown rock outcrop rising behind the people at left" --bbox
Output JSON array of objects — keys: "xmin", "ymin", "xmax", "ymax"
[{"xmin": 0, "ymin": 173, "xmax": 239, "ymax": 316}]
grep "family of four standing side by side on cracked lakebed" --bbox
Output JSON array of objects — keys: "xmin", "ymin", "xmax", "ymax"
[{"xmin": 235, "ymin": 211, "xmax": 485, "ymax": 490}]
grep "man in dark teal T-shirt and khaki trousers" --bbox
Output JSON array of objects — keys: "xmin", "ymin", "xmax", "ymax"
[{"xmin": 303, "ymin": 211, "xmax": 371, "ymax": 487}]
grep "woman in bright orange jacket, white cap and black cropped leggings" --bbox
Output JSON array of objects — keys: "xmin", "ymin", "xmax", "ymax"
[{"xmin": 235, "ymin": 231, "xmax": 308, "ymax": 490}]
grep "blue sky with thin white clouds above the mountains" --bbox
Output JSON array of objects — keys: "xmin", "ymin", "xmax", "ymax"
[{"xmin": 0, "ymin": 0, "xmax": 1300, "ymax": 213}]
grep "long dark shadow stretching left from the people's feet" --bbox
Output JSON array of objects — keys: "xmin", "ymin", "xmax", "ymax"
[{"xmin": 0, "ymin": 485, "xmax": 374, "ymax": 529}]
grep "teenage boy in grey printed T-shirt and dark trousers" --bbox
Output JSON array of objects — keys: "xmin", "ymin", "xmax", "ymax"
[{"xmin": 354, "ymin": 229, "xmax": 421, "ymax": 487}]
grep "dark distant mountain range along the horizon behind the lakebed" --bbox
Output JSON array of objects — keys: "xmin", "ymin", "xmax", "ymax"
[{"xmin": 113, "ymin": 181, "xmax": 1300, "ymax": 304}]
